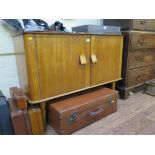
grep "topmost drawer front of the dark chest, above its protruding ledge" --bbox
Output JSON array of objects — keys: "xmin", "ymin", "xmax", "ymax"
[{"xmin": 133, "ymin": 19, "xmax": 155, "ymax": 30}]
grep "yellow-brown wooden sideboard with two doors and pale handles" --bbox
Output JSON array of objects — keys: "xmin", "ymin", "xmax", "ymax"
[{"xmin": 14, "ymin": 32, "xmax": 123, "ymax": 102}]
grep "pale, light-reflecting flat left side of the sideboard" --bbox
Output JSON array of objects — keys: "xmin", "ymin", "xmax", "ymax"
[{"xmin": 13, "ymin": 35, "xmax": 28, "ymax": 93}]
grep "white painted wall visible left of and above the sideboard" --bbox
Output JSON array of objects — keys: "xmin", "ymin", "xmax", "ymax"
[{"xmin": 0, "ymin": 19, "xmax": 102, "ymax": 97}]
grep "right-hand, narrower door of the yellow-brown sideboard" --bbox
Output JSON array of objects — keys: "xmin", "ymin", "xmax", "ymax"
[{"xmin": 91, "ymin": 36, "xmax": 123, "ymax": 85}]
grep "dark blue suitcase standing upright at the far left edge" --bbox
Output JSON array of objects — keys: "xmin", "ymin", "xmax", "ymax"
[{"xmin": 0, "ymin": 91, "xmax": 14, "ymax": 135}]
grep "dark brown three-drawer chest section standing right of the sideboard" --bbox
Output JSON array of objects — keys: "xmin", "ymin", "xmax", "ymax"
[{"xmin": 117, "ymin": 31, "xmax": 155, "ymax": 99}]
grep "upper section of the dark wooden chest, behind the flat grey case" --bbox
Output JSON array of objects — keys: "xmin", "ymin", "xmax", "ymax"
[{"xmin": 103, "ymin": 19, "xmax": 155, "ymax": 31}]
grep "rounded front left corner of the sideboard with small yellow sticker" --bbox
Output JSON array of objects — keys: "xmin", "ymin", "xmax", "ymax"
[{"xmin": 24, "ymin": 34, "xmax": 40, "ymax": 101}]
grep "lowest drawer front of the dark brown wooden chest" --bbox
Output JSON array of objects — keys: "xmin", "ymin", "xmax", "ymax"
[{"xmin": 128, "ymin": 65, "xmax": 155, "ymax": 87}]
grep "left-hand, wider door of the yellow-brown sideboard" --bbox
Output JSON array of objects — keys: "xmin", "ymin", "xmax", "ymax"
[{"xmin": 35, "ymin": 34, "xmax": 90, "ymax": 98}]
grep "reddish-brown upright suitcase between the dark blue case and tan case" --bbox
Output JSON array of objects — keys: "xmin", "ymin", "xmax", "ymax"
[{"xmin": 9, "ymin": 99, "xmax": 32, "ymax": 135}]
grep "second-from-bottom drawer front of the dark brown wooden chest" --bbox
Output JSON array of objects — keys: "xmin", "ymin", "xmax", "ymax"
[{"xmin": 129, "ymin": 49, "xmax": 155, "ymax": 69}]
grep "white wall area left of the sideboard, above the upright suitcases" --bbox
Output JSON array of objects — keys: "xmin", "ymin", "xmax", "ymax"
[{"xmin": 0, "ymin": 21, "xmax": 19, "ymax": 96}]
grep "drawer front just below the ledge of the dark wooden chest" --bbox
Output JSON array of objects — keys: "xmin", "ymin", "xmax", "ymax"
[{"xmin": 131, "ymin": 33, "xmax": 155, "ymax": 49}]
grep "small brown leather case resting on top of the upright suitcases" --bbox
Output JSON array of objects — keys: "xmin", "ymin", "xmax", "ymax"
[{"xmin": 10, "ymin": 87, "xmax": 27, "ymax": 110}]
